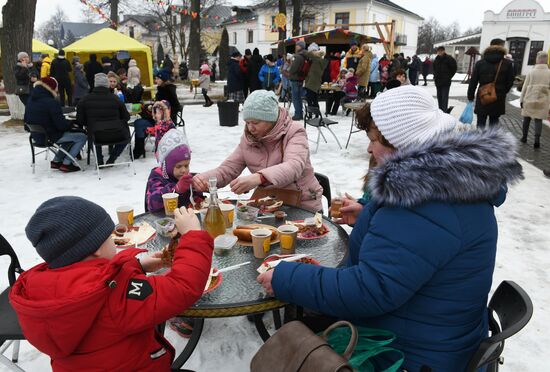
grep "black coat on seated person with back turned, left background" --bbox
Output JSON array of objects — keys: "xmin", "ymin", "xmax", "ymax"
[{"xmin": 76, "ymin": 87, "xmax": 130, "ymax": 142}]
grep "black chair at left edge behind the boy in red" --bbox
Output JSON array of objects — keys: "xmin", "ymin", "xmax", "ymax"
[{"xmin": 0, "ymin": 235, "xmax": 25, "ymax": 371}]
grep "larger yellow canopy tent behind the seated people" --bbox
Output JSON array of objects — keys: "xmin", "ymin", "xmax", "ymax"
[{"xmin": 63, "ymin": 28, "xmax": 153, "ymax": 90}]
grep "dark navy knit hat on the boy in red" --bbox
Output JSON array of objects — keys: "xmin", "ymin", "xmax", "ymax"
[{"xmin": 25, "ymin": 196, "xmax": 115, "ymax": 269}]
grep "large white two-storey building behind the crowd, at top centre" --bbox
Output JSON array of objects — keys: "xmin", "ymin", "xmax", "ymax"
[{"xmin": 224, "ymin": 0, "xmax": 423, "ymax": 56}]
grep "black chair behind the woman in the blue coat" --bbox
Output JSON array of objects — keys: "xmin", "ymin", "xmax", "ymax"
[{"xmin": 466, "ymin": 280, "xmax": 533, "ymax": 372}]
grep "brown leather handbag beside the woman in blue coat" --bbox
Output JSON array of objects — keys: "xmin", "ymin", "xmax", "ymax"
[{"xmin": 250, "ymin": 320, "xmax": 357, "ymax": 372}]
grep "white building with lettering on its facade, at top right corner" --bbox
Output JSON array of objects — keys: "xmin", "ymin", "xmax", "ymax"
[{"xmin": 480, "ymin": 0, "xmax": 550, "ymax": 75}]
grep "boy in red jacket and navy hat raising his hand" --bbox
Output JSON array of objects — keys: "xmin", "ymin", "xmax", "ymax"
[{"xmin": 9, "ymin": 196, "xmax": 213, "ymax": 372}]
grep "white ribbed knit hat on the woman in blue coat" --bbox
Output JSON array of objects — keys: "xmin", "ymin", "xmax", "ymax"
[{"xmin": 370, "ymin": 85, "xmax": 456, "ymax": 149}]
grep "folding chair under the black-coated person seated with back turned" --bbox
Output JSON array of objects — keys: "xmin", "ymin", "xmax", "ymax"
[{"xmin": 88, "ymin": 120, "xmax": 136, "ymax": 179}]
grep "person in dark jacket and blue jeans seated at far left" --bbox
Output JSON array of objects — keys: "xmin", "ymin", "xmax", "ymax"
[{"xmin": 25, "ymin": 77, "xmax": 86, "ymax": 172}]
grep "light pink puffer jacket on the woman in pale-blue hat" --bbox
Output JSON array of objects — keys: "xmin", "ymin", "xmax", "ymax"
[{"xmin": 201, "ymin": 108, "xmax": 323, "ymax": 212}]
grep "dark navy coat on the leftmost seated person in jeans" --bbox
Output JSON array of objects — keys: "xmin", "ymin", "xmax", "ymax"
[{"xmin": 25, "ymin": 81, "xmax": 71, "ymax": 144}]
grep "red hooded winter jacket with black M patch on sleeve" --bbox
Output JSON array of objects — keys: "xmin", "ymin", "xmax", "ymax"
[{"xmin": 9, "ymin": 231, "xmax": 213, "ymax": 372}]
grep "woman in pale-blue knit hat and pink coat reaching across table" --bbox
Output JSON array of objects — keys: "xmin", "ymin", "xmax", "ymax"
[{"xmin": 193, "ymin": 90, "xmax": 323, "ymax": 212}]
